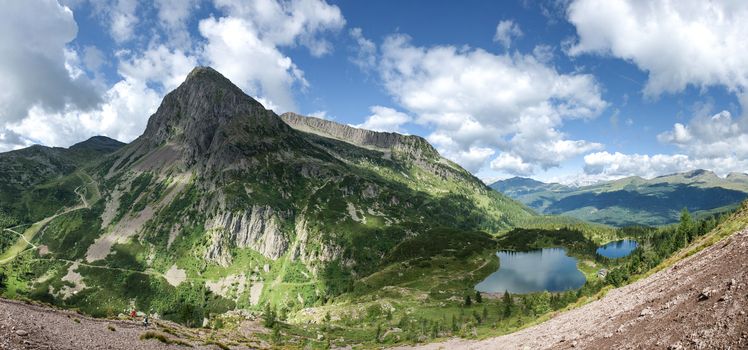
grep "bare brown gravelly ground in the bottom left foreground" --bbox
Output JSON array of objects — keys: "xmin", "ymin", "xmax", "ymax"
[{"xmin": 0, "ymin": 299, "xmax": 268, "ymax": 350}]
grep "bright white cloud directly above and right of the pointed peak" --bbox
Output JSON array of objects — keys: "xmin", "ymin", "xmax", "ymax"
[{"xmin": 199, "ymin": 0, "xmax": 345, "ymax": 112}]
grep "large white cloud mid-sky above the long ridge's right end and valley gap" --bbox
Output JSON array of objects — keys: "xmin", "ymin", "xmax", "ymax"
[{"xmin": 378, "ymin": 35, "xmax": 607, "ymax": 174}]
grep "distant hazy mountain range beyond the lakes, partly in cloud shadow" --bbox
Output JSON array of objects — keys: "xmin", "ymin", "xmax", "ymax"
[{"xmin": 490, "ymin": 170, "xmax": 748, "ymax": 226}]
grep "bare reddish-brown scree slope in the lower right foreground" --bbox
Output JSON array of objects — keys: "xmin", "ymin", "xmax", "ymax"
[{"xmin": 400, "ymin": 230, "xmax": 748, "ymax": 350}]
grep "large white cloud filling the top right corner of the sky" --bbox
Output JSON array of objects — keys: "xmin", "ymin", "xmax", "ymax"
[{"xmin": 567, "ymin": 0, "xmax": 748, "ymax": 96}]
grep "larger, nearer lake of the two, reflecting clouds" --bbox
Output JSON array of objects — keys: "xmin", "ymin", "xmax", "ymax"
[{"xmin": 475, "ymin": 248, "xmax": 585, "ymax": 293}]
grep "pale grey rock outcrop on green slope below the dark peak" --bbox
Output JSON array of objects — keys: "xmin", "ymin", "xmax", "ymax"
[{"xmin": 205, "ymin": 205, "xmax": 289, "ymax": 265}]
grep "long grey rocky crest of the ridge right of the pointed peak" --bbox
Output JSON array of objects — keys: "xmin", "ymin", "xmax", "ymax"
[{"xmin": 280, "ymin": 112, "xmax": 439, "ymax": 159}]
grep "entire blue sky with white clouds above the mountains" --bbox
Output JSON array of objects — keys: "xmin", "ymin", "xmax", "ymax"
[{"xmin": 0, "ymin": 0, "xmax": 748, "ymax": 183}]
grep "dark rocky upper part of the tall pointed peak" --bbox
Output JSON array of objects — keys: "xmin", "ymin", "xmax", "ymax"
[{"xmin": 113, "ymin": 67, "xmax": 299, "ymax": 173}]
